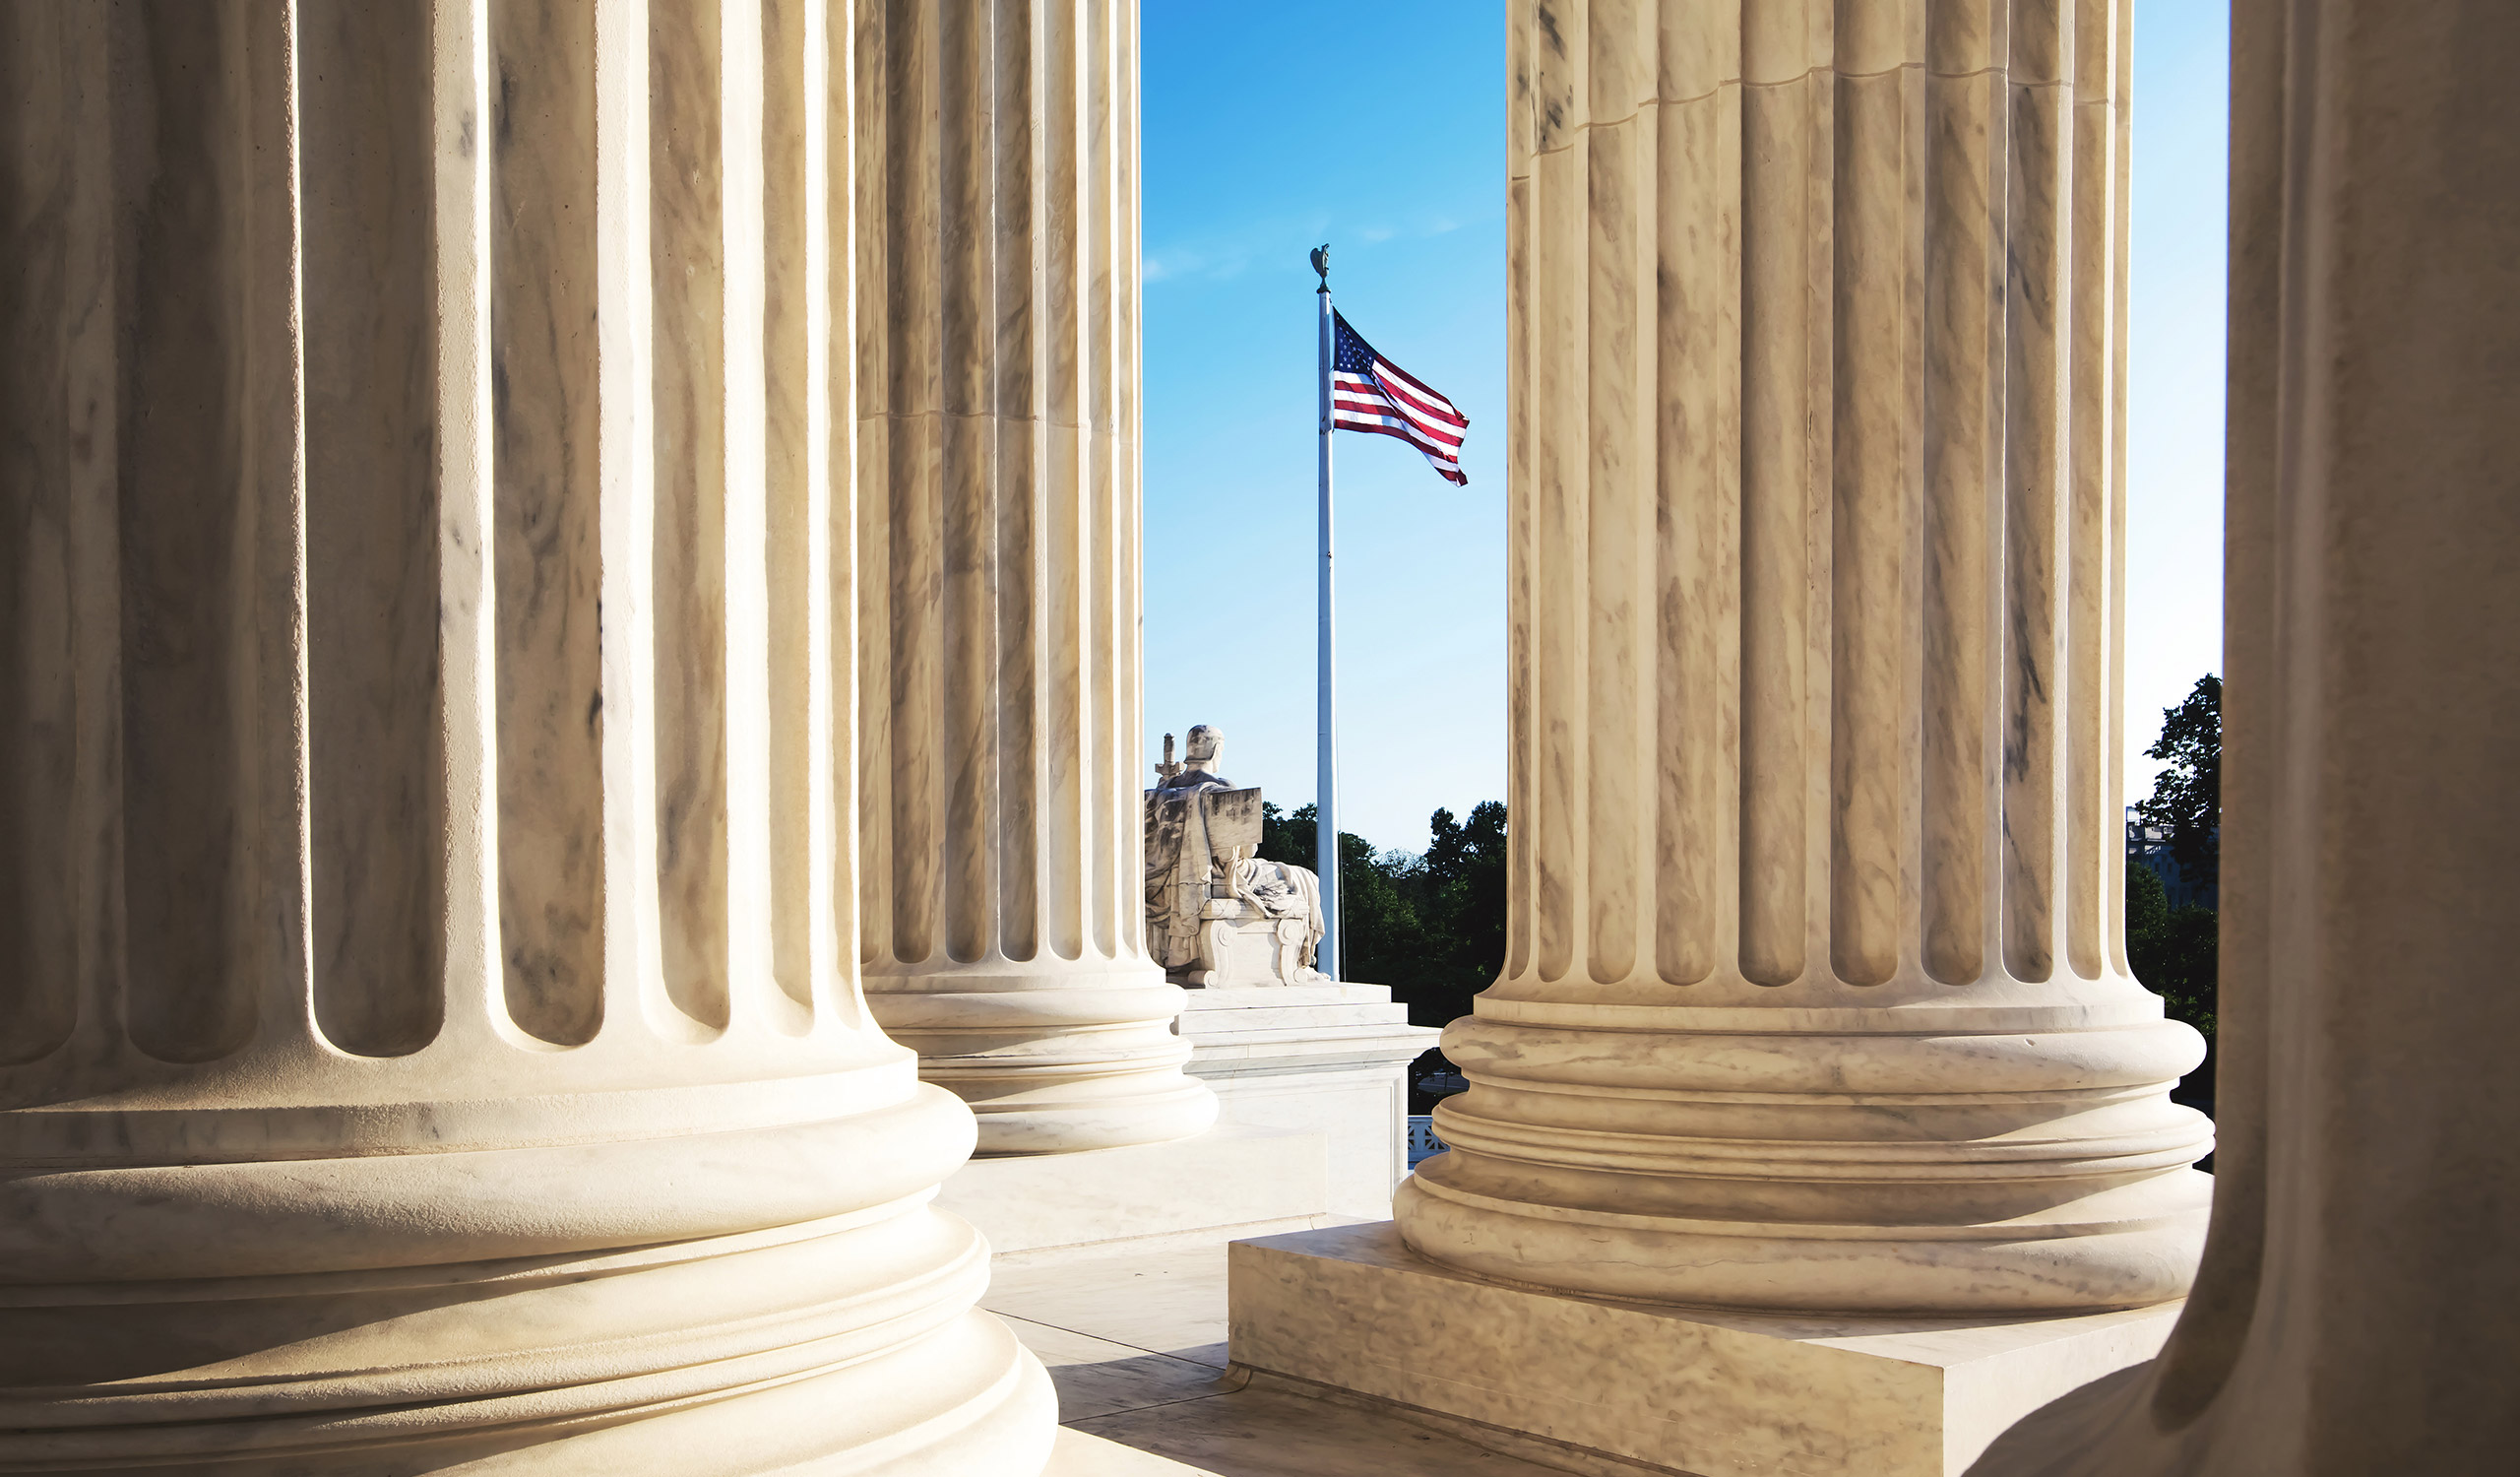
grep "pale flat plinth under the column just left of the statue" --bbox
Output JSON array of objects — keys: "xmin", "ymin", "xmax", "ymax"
[{"xmin": 937, "ymin": 1124, "xmax": 1331, "ymax": 1255}]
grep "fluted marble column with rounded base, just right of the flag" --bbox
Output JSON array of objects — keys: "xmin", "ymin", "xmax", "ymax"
[{"xmin": 1396, "ymin": 0, "xmax": 2210, "ymax": 1314}]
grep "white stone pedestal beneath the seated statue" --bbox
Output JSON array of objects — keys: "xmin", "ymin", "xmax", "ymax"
[{"xmin": 1179, "ymin": 981, "xmax": 1441, "ymax": 1220}]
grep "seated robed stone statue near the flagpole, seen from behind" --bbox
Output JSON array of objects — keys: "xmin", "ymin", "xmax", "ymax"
[{"xmin": 1147, "ymin": 724, "xmax": 1328, "ymax": 988}]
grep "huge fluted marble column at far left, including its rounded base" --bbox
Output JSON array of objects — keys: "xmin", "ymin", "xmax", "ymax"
[{"xmin": 0, "ymin": 0, "xmax": 1056, "ymax": 1477}]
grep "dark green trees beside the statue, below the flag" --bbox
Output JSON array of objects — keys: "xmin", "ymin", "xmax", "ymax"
[{"xmin": 1260, "ymin": 799, "xmax": 1504, "ymax": 1026}]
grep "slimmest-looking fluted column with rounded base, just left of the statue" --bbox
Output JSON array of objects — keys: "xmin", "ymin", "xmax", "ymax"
[{"xmin": 856, "ymin": 0, "xmax": 1217, "ymax": 1154}]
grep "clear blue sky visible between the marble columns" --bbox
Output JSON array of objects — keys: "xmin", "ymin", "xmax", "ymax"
[{"xmin": 1142, "ymin": 0, "xmax": 2228, "ymax": 850}]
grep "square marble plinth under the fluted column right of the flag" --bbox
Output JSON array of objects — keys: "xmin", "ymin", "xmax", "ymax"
[{"xmin": 1228, "ymin": 1222, "xmax": 2182, "ymax": 1477}]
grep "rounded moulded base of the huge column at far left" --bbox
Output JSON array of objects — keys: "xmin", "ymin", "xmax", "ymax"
[{"xmin": 0, "ymin": 1073, "xmax": 1058, "ymax": 1477}]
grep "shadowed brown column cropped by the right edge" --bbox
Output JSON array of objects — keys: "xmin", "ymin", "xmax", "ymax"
[{"xmin": 1973, "ymin": 0, "xmax": 2520, "ymax": 1477}]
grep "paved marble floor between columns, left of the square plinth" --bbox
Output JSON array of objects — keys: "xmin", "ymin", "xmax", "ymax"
[{"xmin": 1008, "ymin": 1240, "xmax": 1565, "ymax": 1477}]
